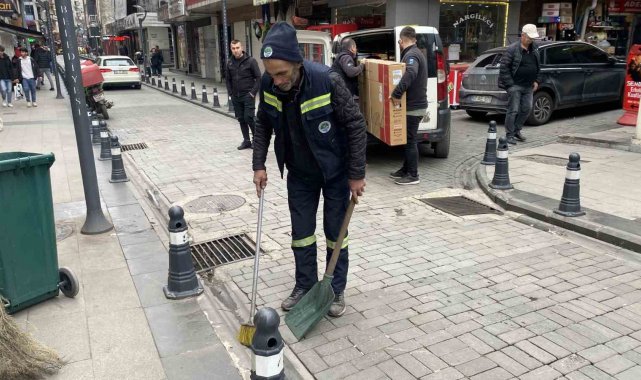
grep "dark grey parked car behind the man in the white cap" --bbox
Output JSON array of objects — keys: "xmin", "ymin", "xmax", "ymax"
[{"xmin": 459, "ymin": 41, "xmax": 625, "ymax": 125}]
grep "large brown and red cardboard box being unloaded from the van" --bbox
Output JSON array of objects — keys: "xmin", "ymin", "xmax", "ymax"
[{"xmin": 359, "ymin": 59, "xmax": 407, "ymax": 146}]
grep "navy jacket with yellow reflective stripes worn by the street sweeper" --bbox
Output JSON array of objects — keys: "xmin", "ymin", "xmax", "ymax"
[{"xmin": 252, "ymin": 61, "xmax": 367, "ymax": 181}]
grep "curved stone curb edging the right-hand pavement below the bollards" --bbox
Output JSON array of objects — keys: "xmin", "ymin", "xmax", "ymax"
[{"xmin": 476, "ymin": 165, "xmax": 641, "ymax": 253}]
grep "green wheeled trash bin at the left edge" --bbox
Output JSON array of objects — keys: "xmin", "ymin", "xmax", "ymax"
[{"xmin": 0, "ymin": 152, "xmax": 78, "ymax": 314}]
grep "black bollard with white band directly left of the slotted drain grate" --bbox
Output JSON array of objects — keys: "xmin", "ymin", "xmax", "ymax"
[{"xmin": 162, "ymin": 206, "xmax": 203, "ymax": 299}]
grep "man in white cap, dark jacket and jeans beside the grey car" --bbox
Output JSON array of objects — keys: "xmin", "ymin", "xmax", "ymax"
[{"xmin": 499, "ymin": 24, "xmax": 541, "ymax": 145}]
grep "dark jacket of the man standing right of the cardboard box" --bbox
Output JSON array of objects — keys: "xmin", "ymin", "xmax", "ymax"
[{"xmin": 392, "ymin": 44, "xmax": 427, "ymax": 111}]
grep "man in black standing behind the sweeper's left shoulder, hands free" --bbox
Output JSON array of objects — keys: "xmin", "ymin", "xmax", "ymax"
[{"xmin": 225, "ymin": 40, "xmax": 260, "ymax": 150}]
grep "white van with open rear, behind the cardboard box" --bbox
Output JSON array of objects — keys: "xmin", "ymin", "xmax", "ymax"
[{"xmin": 297, "ymin": 26, "xmax": 451, "ymax": 158}]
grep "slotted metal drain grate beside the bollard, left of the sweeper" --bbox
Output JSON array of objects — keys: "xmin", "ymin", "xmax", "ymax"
[{"xmin": 191, "ymin": 234, "xmax": 256, "ymax": 273}]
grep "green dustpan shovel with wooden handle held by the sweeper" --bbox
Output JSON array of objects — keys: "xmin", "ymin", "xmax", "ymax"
[{"xmin": 285, "ymin": 196, "xmax": 358, "ymax": 340}]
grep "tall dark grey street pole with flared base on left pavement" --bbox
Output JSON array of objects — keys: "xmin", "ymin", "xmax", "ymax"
[{"xmin": 55, "ymin": 0, "xmax": 113, "ymax": 235}]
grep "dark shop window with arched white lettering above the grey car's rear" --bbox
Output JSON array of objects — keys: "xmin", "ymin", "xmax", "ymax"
[{"xmin": 439, "ymin": 0, "xmax": 508, "ymax": 62}]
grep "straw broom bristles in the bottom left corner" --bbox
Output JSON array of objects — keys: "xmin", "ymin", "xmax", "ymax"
[{"xmin": 0, "ymin": 302, "xmax": 64, "ymax": 379}]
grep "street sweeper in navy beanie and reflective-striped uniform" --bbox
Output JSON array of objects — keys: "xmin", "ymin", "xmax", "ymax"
[{"xmin": 253, "ymin": 22, "xmax": 367, "ymax": 317}]
